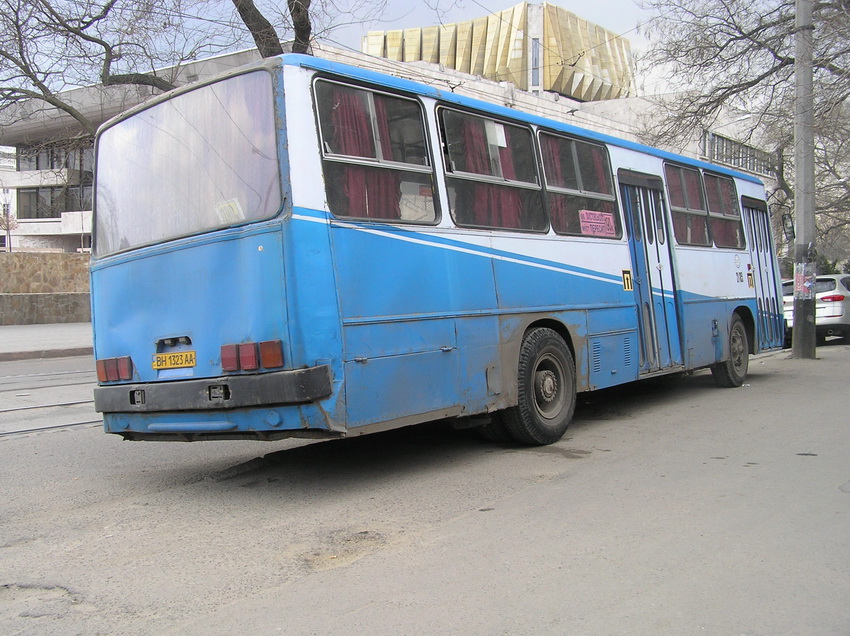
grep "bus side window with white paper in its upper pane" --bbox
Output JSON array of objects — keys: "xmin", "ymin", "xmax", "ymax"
[{"xmin": 440, "ymin": 109, "xmax": 547, "ymax": 232}]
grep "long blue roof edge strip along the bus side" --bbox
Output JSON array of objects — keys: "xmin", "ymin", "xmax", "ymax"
[{"xmin": 281, "ymin": 53, "xmax": 763, "ymax": 185}]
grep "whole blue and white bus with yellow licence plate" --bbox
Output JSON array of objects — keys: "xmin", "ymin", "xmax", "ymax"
[{"xmin": 91, "ymin": 55, "xmax": 783, "ymax": 444}]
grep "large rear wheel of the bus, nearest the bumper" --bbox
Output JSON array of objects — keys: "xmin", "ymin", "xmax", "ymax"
[{"xmin": 502, "ymin": 328, "xmax": 576, "ymax": 445}]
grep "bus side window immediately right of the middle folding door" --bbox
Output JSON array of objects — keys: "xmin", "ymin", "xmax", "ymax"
[{"xmin": 664, "ymin": 164, "xmax": 711, "ymax": 247}]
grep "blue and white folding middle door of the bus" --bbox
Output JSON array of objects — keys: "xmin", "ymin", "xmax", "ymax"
[{"xmin": 618, "ymin": 170, "xmax": 682, "ymax": 373}]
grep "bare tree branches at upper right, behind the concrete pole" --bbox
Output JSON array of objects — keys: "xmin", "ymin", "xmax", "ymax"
[{"xmin": 641, "ymin": 0, "xmax": 850, "ymax": 257}]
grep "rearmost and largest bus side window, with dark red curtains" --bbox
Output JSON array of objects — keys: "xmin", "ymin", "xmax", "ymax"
[{"xmin": 316, "ymin": 81, "xmax": 437, "ymax": 224}]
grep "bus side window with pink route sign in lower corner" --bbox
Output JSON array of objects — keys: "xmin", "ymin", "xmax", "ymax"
[{"xmin": 540, "ymin": 133, "xmax": 623, "ymax": 239}]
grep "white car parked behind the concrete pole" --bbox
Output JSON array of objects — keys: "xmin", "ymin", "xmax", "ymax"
[{"xmin": 782, "ymin": 274, "xmax": 850, "ymax": 343}]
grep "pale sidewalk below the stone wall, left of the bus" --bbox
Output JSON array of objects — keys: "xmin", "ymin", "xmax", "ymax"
[{"xmin": 0, "ymin": 322, "xmax": 92, "ymax": 362}]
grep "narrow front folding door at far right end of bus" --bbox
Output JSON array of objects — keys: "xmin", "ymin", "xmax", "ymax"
[{"xmin": 743, "ymin": 197, "xmax": 785, "ymax": 349}]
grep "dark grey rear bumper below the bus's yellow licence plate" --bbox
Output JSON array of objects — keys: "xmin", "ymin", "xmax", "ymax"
[{"xmin": 94, "ymin": 365, "xmax": 332, "ymax": 413}]
